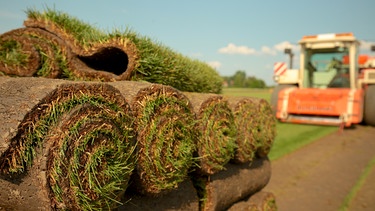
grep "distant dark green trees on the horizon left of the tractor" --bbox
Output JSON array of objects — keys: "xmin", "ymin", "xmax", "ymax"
[{"xmin": 223, "ymin": 70, "xmax": 267, "ymax": 88}]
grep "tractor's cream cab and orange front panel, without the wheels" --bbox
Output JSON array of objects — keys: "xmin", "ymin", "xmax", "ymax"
[{"xmin": 271, "ymin": 33, "xmax": 363, "ymax": 126}]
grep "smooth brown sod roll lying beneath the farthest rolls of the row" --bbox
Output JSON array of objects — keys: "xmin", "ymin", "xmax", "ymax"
[{"xmin": 194, "ymin": 158, "xmax": 271, "ymax": 211}]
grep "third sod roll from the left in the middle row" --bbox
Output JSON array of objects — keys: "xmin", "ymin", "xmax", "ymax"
[{"xmin": 185, "ymin": 92, "xmax": 237, "ymax": 175}]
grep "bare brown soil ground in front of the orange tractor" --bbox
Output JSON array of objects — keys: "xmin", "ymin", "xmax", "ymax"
[{"xmin": 265, "ymin": 125, "xmax": 375, "ymax": 211}]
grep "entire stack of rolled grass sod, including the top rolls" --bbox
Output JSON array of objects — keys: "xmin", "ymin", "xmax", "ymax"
[{"xmin": 0, "ymin": 9, "xmax": 276, "ymax": 210}]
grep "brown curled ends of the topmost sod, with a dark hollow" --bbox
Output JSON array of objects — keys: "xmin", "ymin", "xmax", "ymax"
[{"xmin": 0, "ymin": 19, "xmax": 138, "ymax": 81}]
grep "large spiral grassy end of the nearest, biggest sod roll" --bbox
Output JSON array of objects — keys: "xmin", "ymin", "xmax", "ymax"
[{"xmin": 0, "ymin": 83, "xmax": 136, "ymax": 210}]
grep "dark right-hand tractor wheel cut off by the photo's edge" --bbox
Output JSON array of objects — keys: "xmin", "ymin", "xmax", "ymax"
[{"xmin": 363, "ymin": 85, "xmax": 375, "ymax": 126}]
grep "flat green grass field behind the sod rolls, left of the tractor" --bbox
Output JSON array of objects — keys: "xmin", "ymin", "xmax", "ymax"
[{"xmin": 223, "ymin": 88, "xmax": 338, "ymax": 160}]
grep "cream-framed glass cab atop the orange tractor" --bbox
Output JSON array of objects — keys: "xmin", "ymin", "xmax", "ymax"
[{"xmin": 299, "ymin": 33, "xmax": 358, "ymax": 89}]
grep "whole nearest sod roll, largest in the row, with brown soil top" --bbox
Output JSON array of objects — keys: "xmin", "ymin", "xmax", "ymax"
[{"xmin": 0, "ymin": 77, "xmax": 136, "ymax": 210}]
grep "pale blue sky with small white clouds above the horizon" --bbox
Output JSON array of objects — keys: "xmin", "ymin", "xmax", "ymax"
[{"xmin": 0, "ymin": 0, "xmax": 375, "ymax": 85}]
